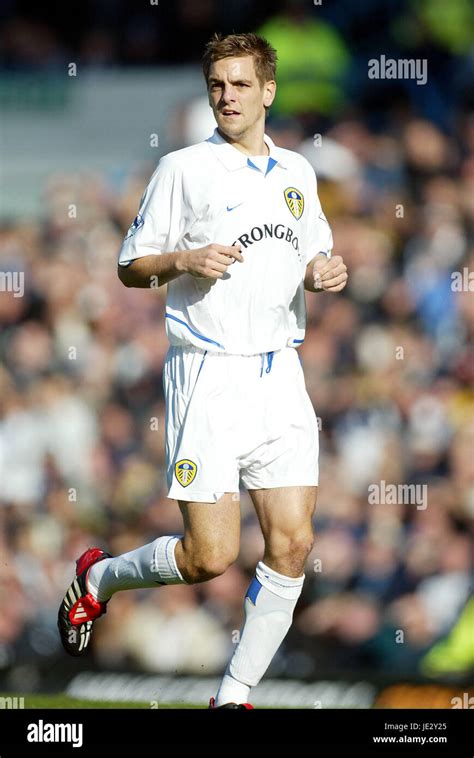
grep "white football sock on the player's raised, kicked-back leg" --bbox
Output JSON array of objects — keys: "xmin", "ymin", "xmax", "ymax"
[{"xmin": 87, "ymin": 536, "xmax": 186, "ymax": 602}]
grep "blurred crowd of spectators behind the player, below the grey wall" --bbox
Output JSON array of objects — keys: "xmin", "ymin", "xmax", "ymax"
[{"xmin": 0, "ymin": 0, "xmax": 474, "ymax": 688}]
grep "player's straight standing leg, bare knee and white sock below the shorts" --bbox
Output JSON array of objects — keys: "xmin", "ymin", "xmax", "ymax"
[{"xmin": 216, "ymin": 487, "xmax": 317, "ymax": 706}]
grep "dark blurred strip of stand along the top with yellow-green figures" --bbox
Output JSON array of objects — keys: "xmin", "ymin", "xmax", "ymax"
[{"xmin": 0, "ymin": 0, "xmax": 474, "ymax": 128}]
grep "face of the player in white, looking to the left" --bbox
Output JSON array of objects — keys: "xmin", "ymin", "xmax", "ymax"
[{"xmin": 208, "ymin": 55, "xmax": 275, "ymax": 139}]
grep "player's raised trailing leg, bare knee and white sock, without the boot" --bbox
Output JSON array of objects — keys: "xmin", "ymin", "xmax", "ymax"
[{"xmin": 88, "ymin": 493, "xmax": 240, "ymax": 601}]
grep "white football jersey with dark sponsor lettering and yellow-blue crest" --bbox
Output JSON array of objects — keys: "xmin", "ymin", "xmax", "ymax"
[{"xmin": 119, "ymin": 129, "xmax": 332, "ymax": 355}]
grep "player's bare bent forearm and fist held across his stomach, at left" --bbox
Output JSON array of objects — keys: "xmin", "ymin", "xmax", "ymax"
[{"xmin": 117, "ymin": 243, "xmax": 244, "ymax": 288}]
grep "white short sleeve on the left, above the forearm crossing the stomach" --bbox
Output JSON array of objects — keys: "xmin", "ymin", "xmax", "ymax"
[{"xmin": 118, "ymin": 156, "xmax": 185, "ymax": 266}]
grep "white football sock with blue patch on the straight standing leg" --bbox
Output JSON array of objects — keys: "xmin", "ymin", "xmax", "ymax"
[{"xmin": 216, "ymin": 561, "xmax": 304, "ymax": 706}]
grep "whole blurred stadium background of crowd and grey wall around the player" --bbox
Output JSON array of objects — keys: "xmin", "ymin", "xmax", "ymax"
[{"xmin": 0, "ymin": 0, "xmax": 474, "ymax": 707}]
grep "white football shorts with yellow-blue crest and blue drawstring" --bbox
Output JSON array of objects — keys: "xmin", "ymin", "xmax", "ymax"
[{"xmin": 163, "ymin": 345, "xmax": 319, "ymax": 503}]
